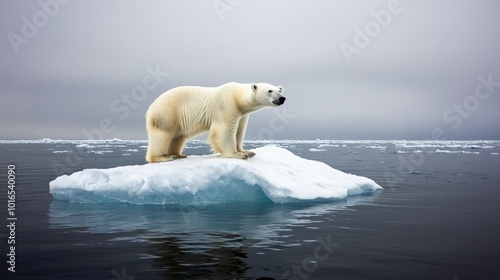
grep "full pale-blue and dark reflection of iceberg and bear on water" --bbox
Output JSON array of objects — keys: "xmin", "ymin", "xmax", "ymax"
[{"xmin": 49, "ymin": 194, "xmax": 377, "ymax": 279}]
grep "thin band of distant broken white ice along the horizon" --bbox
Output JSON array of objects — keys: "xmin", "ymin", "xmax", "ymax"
[{"xmin": 0, "ymin": 138, "xmax": 500, "ymax": 159}]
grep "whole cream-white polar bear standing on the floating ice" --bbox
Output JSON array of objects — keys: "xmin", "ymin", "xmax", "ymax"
[{"xmin": 146, "ymin": 82, "xmax": 286, "ymax": 162}]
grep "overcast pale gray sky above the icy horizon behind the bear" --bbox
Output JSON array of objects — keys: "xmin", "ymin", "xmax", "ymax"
[{"xmin": 0, "ymin": 0, "xmax": 500, "ymax": 139}]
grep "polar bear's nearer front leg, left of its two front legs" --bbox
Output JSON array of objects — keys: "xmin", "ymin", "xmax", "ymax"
[{"xmin": 208, "ymin": 123, "xmax": 248, "ymax": 159}]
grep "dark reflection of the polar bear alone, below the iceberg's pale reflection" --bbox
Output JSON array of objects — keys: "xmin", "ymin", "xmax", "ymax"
[{"xmin": 143, "ymin": 233, "xmax": 248, "ymax": 279}]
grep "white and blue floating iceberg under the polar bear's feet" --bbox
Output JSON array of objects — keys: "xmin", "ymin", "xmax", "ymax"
[{"xmin": 49, "ymin": 145, "xmax": 382, "ymax": 205}]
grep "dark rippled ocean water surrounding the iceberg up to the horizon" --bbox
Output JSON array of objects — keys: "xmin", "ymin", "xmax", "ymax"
[{"xmin": 0, "ymin": 139, "xmax": 500, "ymax": 280}]
